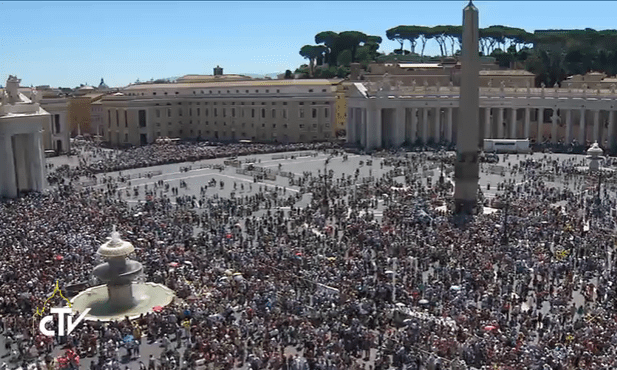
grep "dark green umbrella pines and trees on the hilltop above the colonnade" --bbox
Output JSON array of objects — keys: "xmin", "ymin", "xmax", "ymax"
[{"xmin": 300, "ymin": 25, "xmax": 617, "ymax": 86}]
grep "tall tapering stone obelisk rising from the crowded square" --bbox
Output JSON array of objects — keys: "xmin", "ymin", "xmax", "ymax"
[{"xmin": 454, "ymin": 1, "xmax": 480, "ymax": 214}]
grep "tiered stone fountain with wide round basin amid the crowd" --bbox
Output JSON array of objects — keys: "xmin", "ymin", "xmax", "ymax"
[{"xmin": 71, "ymin": 226, "xmax": 174, "ymax": 321}]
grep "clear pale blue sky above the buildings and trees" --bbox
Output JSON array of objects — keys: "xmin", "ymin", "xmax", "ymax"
[{"xmin": 0, "ymin": 1, "xmax": 617, "ymax": 87}]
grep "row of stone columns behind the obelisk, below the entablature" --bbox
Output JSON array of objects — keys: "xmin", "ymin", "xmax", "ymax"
[{"xmin": 347, "ymin": 100, "xmax": 617, "ymax": 149}]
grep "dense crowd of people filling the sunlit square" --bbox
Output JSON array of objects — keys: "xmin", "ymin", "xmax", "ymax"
[{"xmin": 0, "ymin": 144, "xmax": 617, "ymax": 370}]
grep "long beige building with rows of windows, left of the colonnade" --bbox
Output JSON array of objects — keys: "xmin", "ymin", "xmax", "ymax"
[{"xmin": 98, "ymin": 76, "xmax": 345, "ymax": 146}]
